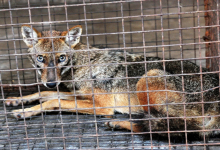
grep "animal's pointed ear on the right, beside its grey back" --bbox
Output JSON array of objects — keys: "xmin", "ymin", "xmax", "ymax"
[{"xmin": 62, "ymin": 25, "xmax": 82, "ymax": 47}]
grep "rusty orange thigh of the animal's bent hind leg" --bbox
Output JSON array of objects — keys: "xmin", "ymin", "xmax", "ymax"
[{"xmin": 136, "ymin": 69, "xmax": 182, "ymax": 112}]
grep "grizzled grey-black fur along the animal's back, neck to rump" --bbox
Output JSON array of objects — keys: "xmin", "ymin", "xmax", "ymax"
[{"xmin": 68, "ymin": 44, "xmax": 219, "ymax": 102}]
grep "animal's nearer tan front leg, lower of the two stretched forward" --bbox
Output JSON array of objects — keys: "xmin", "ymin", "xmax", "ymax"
[{"xmin": 12, "ymin": 99, "xmax": 114, "ymax": 118}]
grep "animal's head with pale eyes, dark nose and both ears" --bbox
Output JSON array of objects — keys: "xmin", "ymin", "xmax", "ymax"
[{"xmin": 21, "ymin": 25, "xmax": 82, "ymax": 88}]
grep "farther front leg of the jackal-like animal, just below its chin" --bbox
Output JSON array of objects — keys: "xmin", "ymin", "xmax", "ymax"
[{"xmin": 5, "ymin": 91, "xmax": 77, "ymax": 106}]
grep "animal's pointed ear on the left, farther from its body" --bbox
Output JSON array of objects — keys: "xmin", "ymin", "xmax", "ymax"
[{"xmin": 21, "ymin": 25, "xmax": 41, "ymax": 47}]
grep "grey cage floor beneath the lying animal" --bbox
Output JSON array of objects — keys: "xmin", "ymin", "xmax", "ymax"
[{"xmin": 0, "ymin": 89, "xmax": 220, "ymax": 150}]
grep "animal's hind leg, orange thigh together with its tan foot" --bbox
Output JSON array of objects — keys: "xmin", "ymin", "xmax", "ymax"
[{"xmin": 106, "ymin": 69, "xmax": 181, "ymax": 132}]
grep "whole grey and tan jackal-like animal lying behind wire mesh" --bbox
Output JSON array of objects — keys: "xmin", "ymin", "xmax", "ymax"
[{"xmin": 5, "ymin": 25, "xmax": 220, "ymax": 137}]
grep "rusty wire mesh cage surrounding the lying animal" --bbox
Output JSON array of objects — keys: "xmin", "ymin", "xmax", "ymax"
[{"xmin": 0, "ymin": 0, "xmax": 220, "ymax": 149}]
